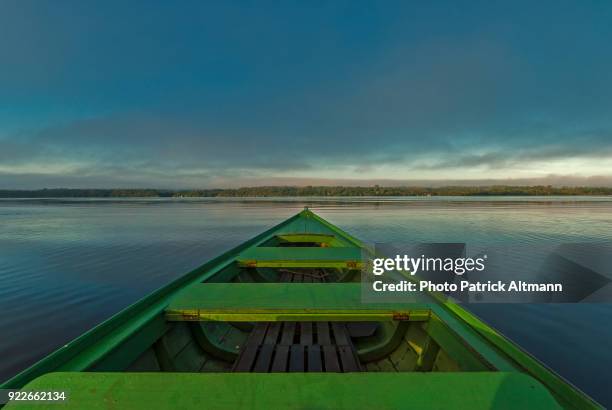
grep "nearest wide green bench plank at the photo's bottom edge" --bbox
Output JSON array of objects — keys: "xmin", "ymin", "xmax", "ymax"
[{"xmin": 7, "ymin": 372, "xmax": 560, "ymax": 410}]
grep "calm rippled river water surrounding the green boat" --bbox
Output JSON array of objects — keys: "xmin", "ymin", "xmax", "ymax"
[{"xmin": 0, "ymin": 197, "xmax": 612, "ymax": 407}]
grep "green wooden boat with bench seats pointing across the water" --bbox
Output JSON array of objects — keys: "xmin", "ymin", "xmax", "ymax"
[{"xmin": 0, "ymin": 210, "xmax": 601, "ymax": 409}]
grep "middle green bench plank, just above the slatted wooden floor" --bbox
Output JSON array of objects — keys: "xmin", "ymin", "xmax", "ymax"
[{"xmin": 166, "ymin": 283, "xmax": 429, "ymax": 321}]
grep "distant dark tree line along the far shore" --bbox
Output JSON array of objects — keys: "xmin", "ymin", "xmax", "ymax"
[{"xmin": 0, "ymin": 185, "xmax": 612, "ymax": 198}]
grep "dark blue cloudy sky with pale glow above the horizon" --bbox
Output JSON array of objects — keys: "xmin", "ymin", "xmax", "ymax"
[{"xmin": 0, "ymin": 0, "xmax": 612, "ymax": 189}]
